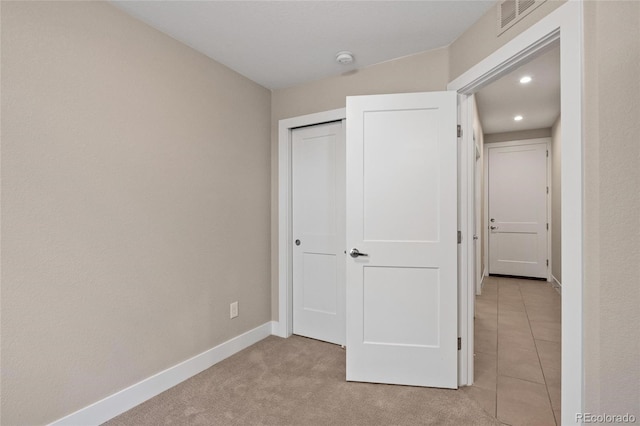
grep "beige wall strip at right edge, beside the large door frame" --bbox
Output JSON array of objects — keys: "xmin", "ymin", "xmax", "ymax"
[{"xmin": 584, "ymin": 1, "xmax": 640, "ymax": 418}]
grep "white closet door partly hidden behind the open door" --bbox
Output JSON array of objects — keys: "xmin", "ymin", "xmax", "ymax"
[{"xmin": 291, "ymin": 121, "xmax": 346, "ymax": 345}]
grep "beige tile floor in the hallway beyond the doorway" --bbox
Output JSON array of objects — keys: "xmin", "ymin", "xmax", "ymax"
[{"xmin": 462, "ymin": 277, "xmax": 561, "ymax": 426}]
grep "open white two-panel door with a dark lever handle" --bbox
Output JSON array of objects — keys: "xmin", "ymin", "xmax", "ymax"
[{"xmin": 347, "ymin": 92, "xmax": 458, "ymax": 388}]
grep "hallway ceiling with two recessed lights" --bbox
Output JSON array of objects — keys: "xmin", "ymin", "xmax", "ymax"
[{"xmin": 476, "ymin": 46, "xmax": 560, "ymax": 134}]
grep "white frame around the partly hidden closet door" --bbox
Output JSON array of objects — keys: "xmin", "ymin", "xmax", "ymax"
[{"xmin": 272, "ymin": 108, "xmax": 347, "ymax": 337}]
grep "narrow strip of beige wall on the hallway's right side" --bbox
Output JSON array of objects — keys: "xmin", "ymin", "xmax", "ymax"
[{"xmin": 551, "ymin": 116, "xmax": 562, "ymax": 284}]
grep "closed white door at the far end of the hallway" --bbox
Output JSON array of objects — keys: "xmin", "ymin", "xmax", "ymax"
[{"xmin": 487, "ymin": 139, "xmax": 549, "ymax": 279}]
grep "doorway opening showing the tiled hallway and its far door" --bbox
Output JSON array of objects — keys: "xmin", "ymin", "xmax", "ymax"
[{"xmin": 460, "ymin": 42, "xmax": 561, "ymax": 424}]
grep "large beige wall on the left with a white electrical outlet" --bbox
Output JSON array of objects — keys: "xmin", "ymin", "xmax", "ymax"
[{"xmin": 1, "ymin": 2, "xmax": 271, "ymax": 425}]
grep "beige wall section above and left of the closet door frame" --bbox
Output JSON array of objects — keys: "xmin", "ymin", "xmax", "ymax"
[{"xmin": 271, "ymin": 48, "xmax": 449, "ymax": 320}]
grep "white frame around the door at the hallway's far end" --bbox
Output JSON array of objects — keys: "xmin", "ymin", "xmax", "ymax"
[{"xmin": 482, "ymin": 137, "xmax": 553, "ymax": 282}]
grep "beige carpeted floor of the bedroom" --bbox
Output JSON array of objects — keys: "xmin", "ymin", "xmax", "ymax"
[{"xmin": 105, "ymin": 336, "xmax": 500, "ymax": 426}]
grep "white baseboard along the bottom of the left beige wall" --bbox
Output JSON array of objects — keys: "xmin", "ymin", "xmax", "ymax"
[{"xmin": 51, "ymin": 321, "xmax": 274, "ymax": 426}]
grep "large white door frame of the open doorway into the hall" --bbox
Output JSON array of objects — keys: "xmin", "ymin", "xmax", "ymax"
[{"xmin": 447, "ymin": 1, "xmax": 584, "ymax": 424}]
